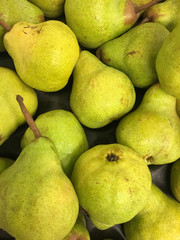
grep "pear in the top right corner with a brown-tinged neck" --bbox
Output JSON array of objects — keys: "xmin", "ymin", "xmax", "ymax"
[{"xmin": 142, "ymin": 0, "xmax": 180, "ymax": 31}]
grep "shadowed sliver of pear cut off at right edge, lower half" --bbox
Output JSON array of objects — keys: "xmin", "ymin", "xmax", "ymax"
[{"xmin": 170, "ymin": 159, "xmax": 180, "ymax": 202}]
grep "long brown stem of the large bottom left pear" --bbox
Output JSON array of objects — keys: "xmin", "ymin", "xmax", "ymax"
[{"xmin": 16, "ymin": 95, "xmax": 42, "ymax": 138}]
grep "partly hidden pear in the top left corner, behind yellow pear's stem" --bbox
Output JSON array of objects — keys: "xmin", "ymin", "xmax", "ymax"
[{"xmin": 0, "ymin": 0, "xmax": 44, "ymax": 52}]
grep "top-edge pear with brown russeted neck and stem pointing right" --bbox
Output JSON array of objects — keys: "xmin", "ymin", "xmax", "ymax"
[{"xmin": 64, "ymin": 0, "xmax": 161, "ymax": 49}]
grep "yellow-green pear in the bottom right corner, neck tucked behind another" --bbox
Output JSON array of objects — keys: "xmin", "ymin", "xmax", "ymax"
[{"xmin": 124, "ymin": 184, "xmax": 180, "ymax": 240}]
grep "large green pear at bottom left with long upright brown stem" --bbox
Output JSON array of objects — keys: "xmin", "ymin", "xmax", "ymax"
[{"xmin": 0, "ymin": 95, "xmax": 79, "ymax": 240}]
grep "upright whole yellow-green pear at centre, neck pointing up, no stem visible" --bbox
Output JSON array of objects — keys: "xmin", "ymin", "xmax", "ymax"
[{"xmin": 70, "ymin": 50, "xmax": 135, "ymax": 128}]
